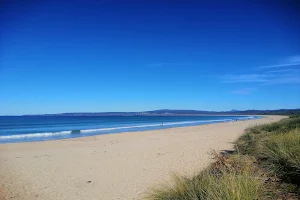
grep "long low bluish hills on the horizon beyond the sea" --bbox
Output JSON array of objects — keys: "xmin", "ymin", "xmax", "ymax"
[{"xmin": 25, "ymin": 109, "xmax": 300, "ymax": 116}]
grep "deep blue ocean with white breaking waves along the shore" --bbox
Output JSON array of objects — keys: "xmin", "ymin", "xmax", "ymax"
[{"xmin": 0, "ymin": 116, "xmax": 259, "ymax": 143}]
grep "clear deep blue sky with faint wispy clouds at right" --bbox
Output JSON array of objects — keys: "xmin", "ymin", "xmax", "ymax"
[{"xmin": 0, "ymin": 0, "xmax": 300, "ymax": 115}]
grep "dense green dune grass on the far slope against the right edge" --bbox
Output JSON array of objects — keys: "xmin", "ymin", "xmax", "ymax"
[{"xmin": 236, "ymin": 116, "xmax": 300, "ymax": 185}]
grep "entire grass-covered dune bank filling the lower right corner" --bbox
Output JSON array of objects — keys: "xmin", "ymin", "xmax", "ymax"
[{"xmin": 146, "ymin": 115, "xmax": 300, "ymax": 200}]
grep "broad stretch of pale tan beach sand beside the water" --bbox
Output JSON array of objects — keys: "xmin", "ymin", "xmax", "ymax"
[{"xmin": 0, "ymin": 116, "xmax": 283, "ymax": 200}]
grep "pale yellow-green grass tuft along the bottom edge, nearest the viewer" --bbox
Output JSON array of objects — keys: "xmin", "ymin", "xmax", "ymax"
[{"xmin": 147, "ymin": 172, "xmax": 263, "ymax": 200}]
